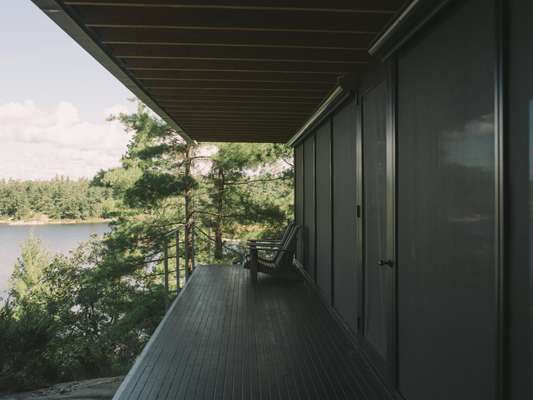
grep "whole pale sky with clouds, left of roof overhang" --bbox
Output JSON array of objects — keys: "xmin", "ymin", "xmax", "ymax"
[{"xmin": 0, "ymin": 0, "xmax": 135, "ymax": 179}]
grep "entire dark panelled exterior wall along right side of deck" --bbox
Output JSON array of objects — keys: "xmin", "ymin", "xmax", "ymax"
[{"xmin": 288, "ymin": 0, "xmax": 516, "ymax": 400}]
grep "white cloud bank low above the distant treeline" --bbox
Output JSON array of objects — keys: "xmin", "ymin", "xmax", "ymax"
[{"xmin": 0, "ymin": 101, "xmax": 130, "ymax": 179}]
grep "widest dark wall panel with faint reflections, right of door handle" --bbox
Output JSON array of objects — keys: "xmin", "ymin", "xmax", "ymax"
[{"xmin": 398, "ymin": 0, "xmax": 497, "ymax": 400}]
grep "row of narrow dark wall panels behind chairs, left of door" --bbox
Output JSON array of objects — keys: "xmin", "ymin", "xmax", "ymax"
[{"xmin": 295, "ymin": 100, "xmax": 360, "ymax": 324}]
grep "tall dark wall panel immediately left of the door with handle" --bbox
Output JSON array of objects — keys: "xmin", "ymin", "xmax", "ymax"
[{"xmin": 332, "ymin": 101, "xmax": 360, "ymax": 331}]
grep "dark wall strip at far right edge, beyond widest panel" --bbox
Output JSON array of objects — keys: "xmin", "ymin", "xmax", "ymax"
[{"xmin": 505, "ymin": 0, "xmax": 533, "ymax": 400}]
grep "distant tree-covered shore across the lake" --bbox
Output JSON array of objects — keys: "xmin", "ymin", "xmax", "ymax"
[{"xmin": 0, "ymin": 177, "xmax": 116, "ymax": 224}]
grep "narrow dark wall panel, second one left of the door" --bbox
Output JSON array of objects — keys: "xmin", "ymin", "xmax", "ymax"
[{"xmin": 316, "ymin": 120, "xmax": 332, "ymax": 302}]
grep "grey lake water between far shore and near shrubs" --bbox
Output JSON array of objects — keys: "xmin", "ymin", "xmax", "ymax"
[{"xmin": 0, "ymin": 223, "xmax": 109, "ymax": 297}]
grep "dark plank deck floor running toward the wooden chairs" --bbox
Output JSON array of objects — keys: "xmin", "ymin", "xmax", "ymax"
[{"xmin": 114, "ymin": 266, "xmax": 389, "ymax": 400}]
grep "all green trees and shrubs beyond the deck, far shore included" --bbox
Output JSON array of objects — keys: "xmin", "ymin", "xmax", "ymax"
[{"xmin": 0, "ymin": 99, "xmax": 293, "ymax": 390}]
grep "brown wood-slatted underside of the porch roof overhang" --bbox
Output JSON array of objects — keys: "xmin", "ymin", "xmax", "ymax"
[{"xmin": 32, "ymin": 0, "xmax": 406, "ymax": 143}]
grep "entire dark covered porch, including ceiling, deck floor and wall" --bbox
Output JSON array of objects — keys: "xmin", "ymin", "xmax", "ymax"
[{"xmin": 33, "ymin": 0, "xmax": 533, "ymax": 400}]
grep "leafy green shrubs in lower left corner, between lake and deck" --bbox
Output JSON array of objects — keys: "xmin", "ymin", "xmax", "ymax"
[{"xmin": 0, "ymin": 239, "xmax": 164, "ymax": 390}]
